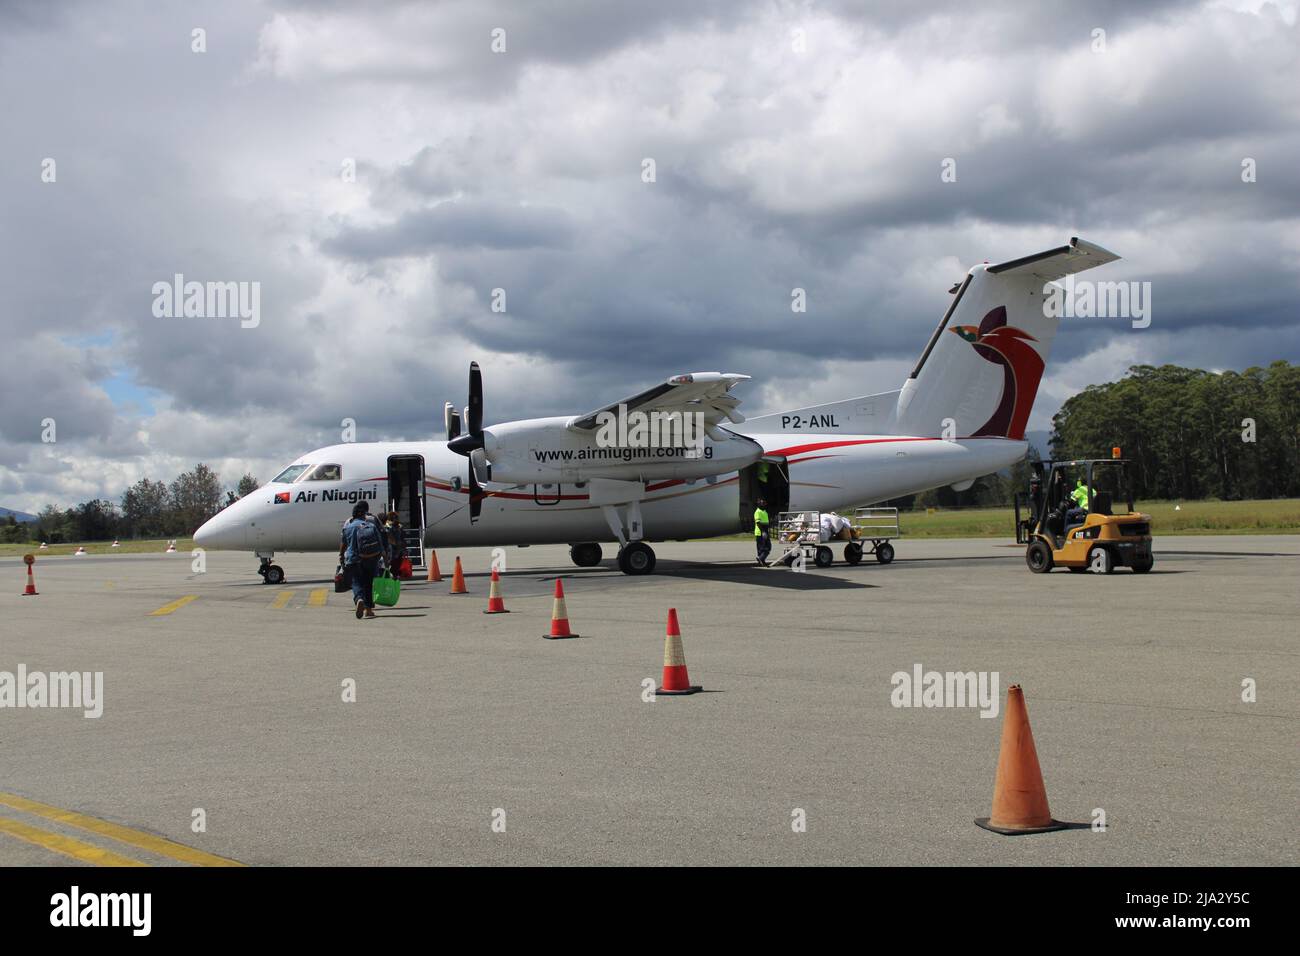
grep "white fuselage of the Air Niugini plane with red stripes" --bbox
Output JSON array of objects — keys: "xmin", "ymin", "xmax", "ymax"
[{"xmin": 195, "ymin": 432, "xmax": 1027, "ymax": 554}]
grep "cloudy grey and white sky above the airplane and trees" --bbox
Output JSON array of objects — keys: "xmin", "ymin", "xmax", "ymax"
[{"xmin": 0, "ymin": 0, "xmax": 1300, "ymax": 511}]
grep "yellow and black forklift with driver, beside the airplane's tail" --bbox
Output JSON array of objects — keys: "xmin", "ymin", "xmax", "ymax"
[{"xmin": 1015, "ymin": 447, "xmax": 1154, "ymax": 574}]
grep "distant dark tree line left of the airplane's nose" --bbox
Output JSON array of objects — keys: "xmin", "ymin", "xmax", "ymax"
[{"xmin": 0, "ymin": 462, "xmax": 257, "ymax": 544}]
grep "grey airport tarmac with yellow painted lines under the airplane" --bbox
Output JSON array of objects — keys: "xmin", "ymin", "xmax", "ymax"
[{"xmin": 0, "ymin": 536, "xmax": 1300, "ymax": 866}]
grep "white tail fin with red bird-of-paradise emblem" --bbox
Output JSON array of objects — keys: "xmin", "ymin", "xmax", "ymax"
[{"xmin": 897, "ymin": 238, "xmax": 1119, "ymax": 438}]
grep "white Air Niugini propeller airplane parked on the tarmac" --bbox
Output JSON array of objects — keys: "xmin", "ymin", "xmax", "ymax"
[{"xmin": 194, "ymin": 238, "xmax": 1119, "ymax": 584}]
